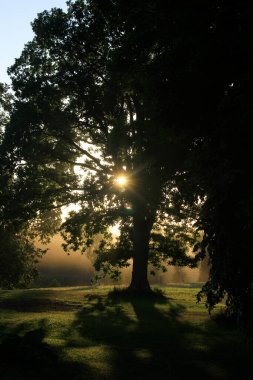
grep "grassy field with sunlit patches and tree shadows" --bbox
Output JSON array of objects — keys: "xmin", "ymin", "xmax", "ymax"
[{"xmin": 0, "ymin": 287, "xmax": 252, "ymax": 380}]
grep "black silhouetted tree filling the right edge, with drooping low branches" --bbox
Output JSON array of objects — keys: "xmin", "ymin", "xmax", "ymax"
[{"xmin": 185, "ymin": 1, "xmax": 253, "ymax": 322}]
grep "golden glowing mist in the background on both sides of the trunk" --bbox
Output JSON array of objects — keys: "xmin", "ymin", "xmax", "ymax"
[{"xmin": 32, "ymin": 235, "xmax": 208, "ymax": 287}]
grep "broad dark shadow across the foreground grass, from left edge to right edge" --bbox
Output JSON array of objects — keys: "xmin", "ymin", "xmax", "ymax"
[{"xmin": 0, "ymin": 294, "xmax": 251, "ymax": 380}]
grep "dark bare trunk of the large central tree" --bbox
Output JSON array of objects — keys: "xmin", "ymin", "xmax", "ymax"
[{"xmin": 129, "ymin": 216, "xmax": 152, "ymax": 293}]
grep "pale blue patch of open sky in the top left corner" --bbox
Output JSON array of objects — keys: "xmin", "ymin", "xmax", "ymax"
[{"xmin": 0, "ymin": 0, "xmax": 66, "ymax": 83}]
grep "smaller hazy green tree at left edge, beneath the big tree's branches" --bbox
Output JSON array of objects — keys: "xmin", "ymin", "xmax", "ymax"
[{"xmin": 0, "ymin": 210, "xmax": 60, "ymax": 289}]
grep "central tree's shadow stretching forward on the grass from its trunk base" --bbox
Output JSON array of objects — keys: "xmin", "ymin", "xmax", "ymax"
[{"xmin": 66, "ymin": 297, "xmax": 198, "ymax": 379}]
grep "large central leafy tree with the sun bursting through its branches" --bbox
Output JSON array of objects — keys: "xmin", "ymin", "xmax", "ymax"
[{"xmin": 2, "ymin": 0, "xmax": 223, "ymax": 291}]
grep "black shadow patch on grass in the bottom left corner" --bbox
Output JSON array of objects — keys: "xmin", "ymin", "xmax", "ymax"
[{"xmin": 0, "ymin": 320, "xmax": 92, "ymax": 380}]
